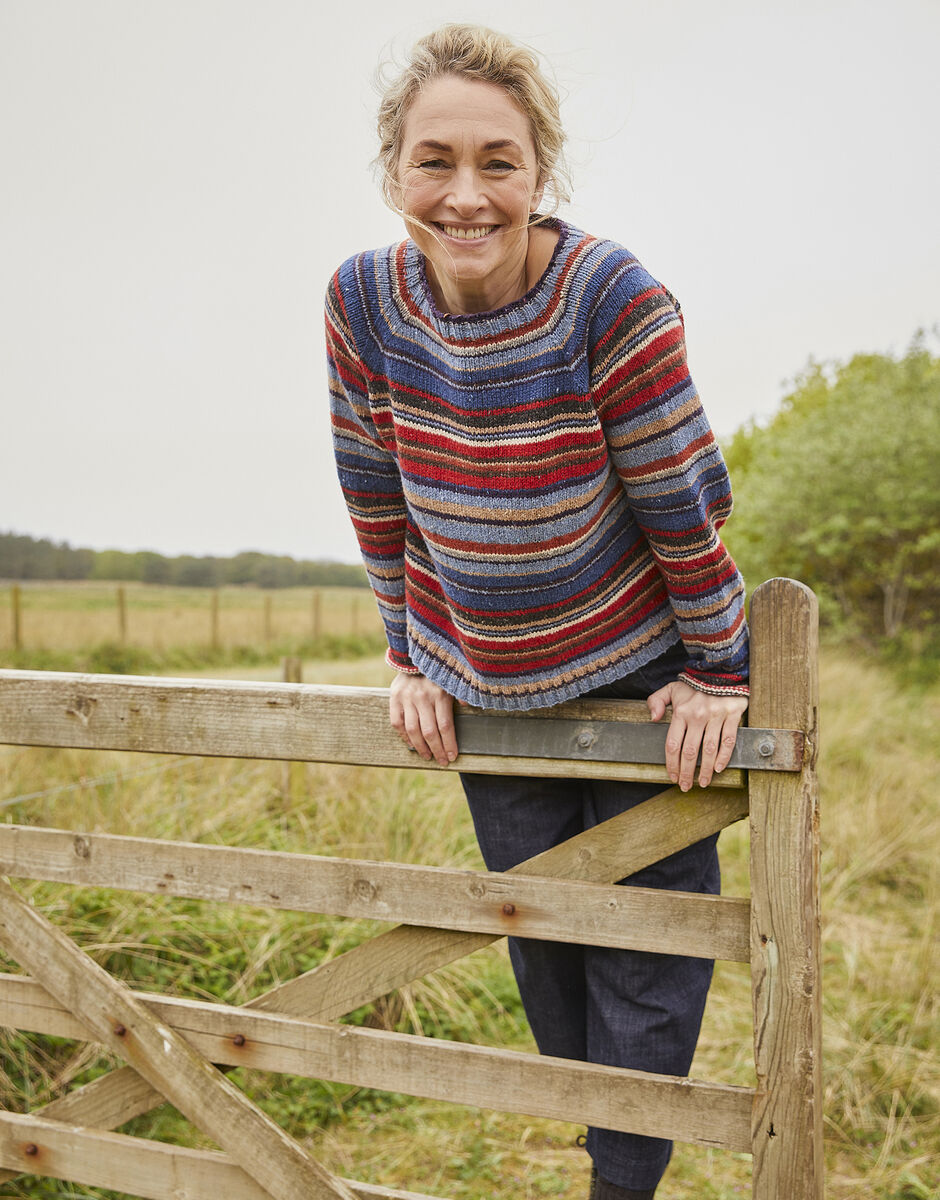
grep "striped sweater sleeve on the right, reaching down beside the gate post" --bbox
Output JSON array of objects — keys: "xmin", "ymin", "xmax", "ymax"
[{"xmin": 591, "ymin": 271, "xmax": 748, "ymax": 695}]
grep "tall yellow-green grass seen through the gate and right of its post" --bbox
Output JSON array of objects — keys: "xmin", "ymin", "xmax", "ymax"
[{"xmin": 0, "ymin": 638, "xmax": 940, "ymax": 1200}]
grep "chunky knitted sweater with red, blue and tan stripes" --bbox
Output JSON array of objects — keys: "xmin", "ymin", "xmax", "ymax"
[{"xmin": 327, "ymin": 221, "xmax": 747, "ymax": 709}]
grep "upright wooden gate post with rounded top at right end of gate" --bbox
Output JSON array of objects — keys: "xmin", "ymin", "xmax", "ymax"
[{"xmin": 749, "ymin": 578, "xmax": 824, "ymax": 1200}]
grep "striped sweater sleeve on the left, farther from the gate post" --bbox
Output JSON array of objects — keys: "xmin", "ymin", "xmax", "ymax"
[{"xmin": 325, "ymin": 271, "xmax": 417, "ymax": 673}]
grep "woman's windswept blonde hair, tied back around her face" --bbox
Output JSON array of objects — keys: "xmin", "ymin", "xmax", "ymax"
[{"xmin": 376, "ymin": 24, "xmax": 569, "ymax": 211}]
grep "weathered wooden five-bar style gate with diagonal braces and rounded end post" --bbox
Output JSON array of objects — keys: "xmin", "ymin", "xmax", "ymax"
[{"xmin": 0, "ymin": 580, "xmax": 822, "ymax": 1200}]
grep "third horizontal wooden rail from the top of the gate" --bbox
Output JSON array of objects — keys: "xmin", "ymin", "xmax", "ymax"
[{"xmin": 0, "ymin": 976, "xmax": 754, "ymax": 1151}]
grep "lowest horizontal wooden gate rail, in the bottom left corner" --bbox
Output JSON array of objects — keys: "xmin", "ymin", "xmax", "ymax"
[{"xmin": 0, "ymin": 1111, "xmax": 433, "ymax": 1200}]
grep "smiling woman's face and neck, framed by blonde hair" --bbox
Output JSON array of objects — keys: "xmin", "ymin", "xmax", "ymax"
[{"xmin": 397, "ymin": 69, "xmax": 541, "ymax": 312}]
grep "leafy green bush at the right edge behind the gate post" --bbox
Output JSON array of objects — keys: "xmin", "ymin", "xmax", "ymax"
[{"xmin": 726, "ymin": 336, "xmax": 940, "ymax": 659}]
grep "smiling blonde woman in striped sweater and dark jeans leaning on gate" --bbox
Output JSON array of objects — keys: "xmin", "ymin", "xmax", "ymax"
[{"xmin": 327, "ymin": 25, "xmax": 747, "ymax": 1200}]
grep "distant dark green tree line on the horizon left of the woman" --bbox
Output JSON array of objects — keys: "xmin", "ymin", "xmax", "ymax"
[{"xmin": 0, "ymin": 533, "xmax": 369, "ymax": 588}]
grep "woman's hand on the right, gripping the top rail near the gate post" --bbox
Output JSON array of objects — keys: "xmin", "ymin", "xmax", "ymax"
[{"xmin": 646, "ymin": 679, "xmax": 748, "ymax": 792}]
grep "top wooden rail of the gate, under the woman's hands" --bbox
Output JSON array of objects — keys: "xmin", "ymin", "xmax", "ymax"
[{"xmin": 0, "ymin": 671, "xmax": 744, "ymax": 788}]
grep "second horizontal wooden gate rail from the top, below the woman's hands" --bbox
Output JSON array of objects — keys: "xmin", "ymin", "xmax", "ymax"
[{"xmin": 0, "ymin": 826, "xmax": 750, "ymax": 962}]
